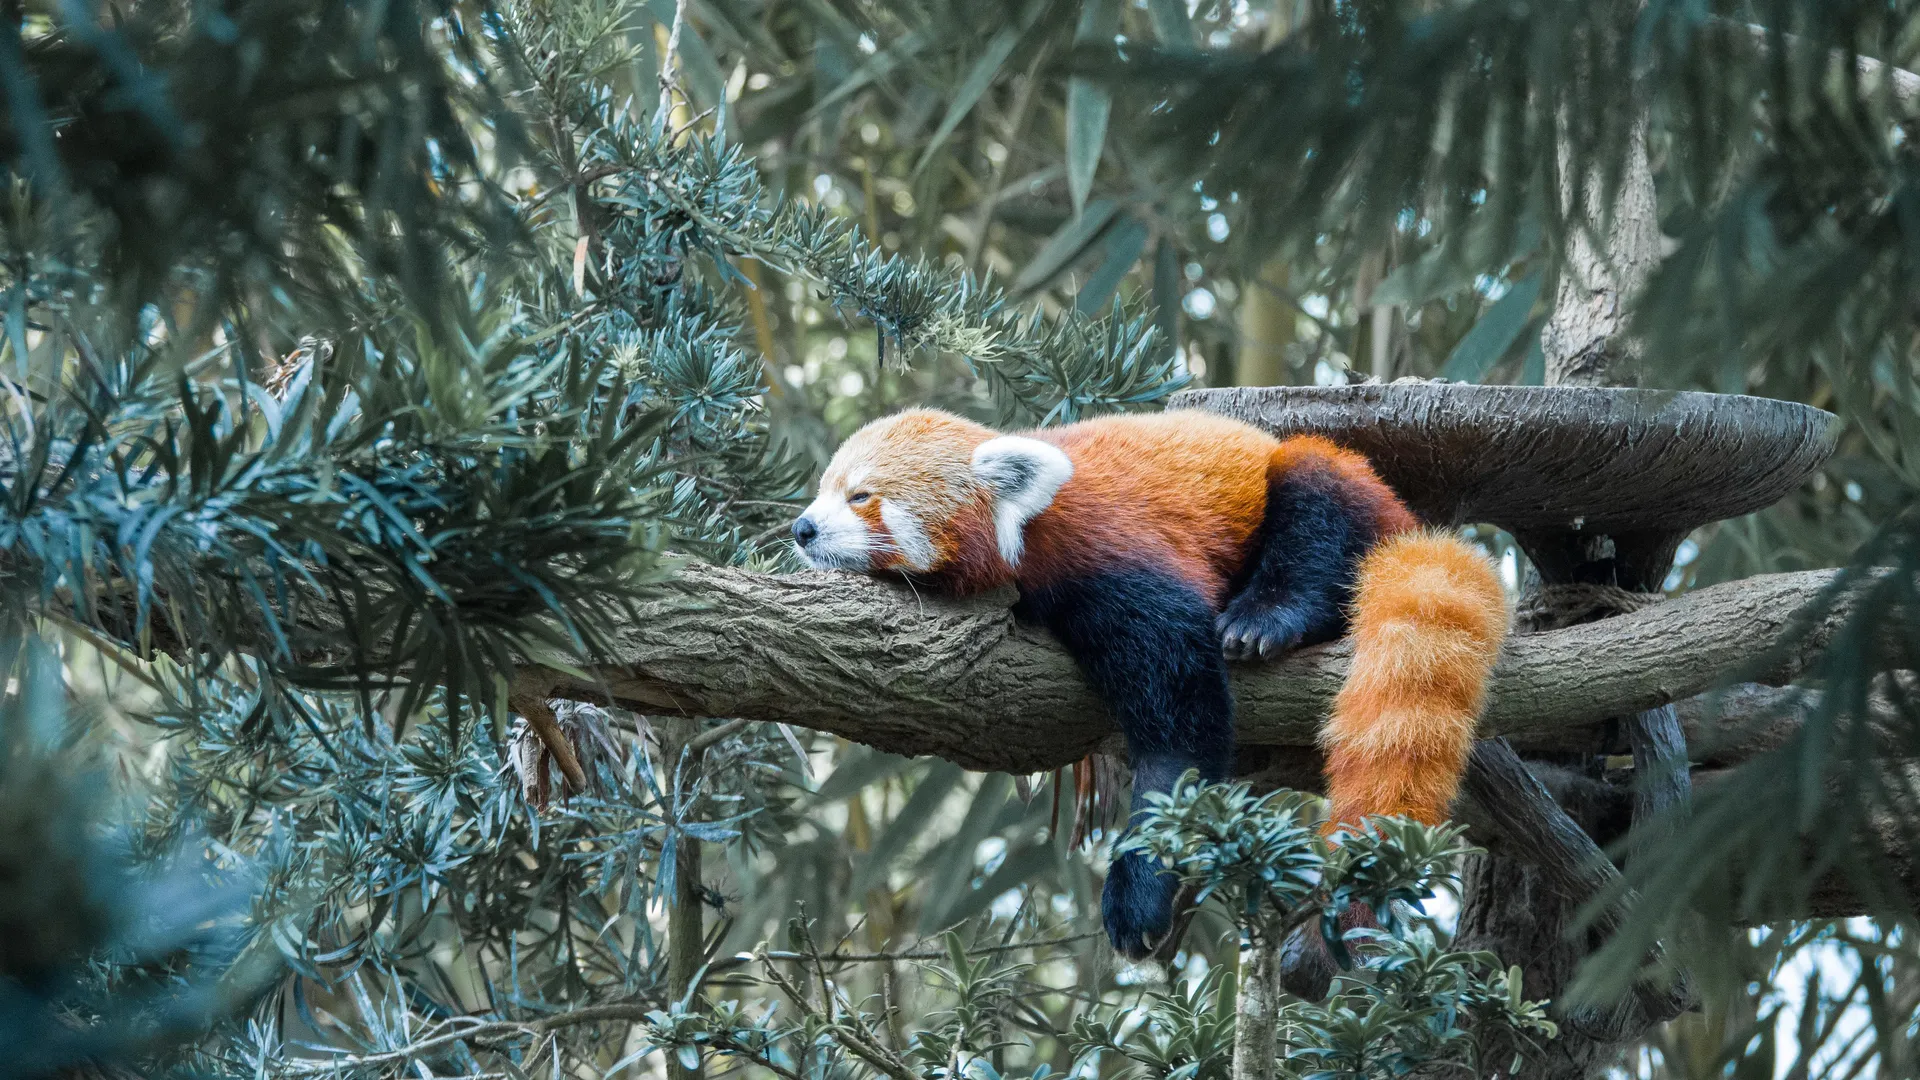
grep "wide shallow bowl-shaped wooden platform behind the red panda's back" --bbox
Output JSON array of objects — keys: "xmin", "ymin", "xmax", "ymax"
[{"xmin": 1169, "ymin": 382, "xmax": 1836, "ymax": 536}]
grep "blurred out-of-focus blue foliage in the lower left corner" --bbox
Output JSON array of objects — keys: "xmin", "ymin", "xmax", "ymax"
[{"xmin": 0, "ymin": 636, "xmax": 278, "ymax": 1078}]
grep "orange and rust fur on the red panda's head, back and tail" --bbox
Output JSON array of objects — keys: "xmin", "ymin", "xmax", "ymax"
[{"xmin": 822, "ymin": 409, "xmax": 1507, "ymax": 828}]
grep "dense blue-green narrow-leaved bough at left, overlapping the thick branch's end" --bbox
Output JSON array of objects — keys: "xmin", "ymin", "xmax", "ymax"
[{"xmin": 0, "ymin": 298, "xmax": 662, "ymax": 715}]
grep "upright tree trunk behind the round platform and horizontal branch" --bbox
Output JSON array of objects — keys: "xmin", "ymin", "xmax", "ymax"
[{"xmin": 1457, "ymin": 96, "xmax": 1693, "ymax": 1080}]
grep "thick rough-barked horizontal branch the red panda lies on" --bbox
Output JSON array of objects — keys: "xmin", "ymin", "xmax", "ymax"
[{"xmin": 551, "ymin": 567, "xmax": 1847, "ymax": 773}]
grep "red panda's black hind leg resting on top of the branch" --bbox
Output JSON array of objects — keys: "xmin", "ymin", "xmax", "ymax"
[{"xmin": 1215, "ymin": 465, "xmax": 1375, "ymax": 659}]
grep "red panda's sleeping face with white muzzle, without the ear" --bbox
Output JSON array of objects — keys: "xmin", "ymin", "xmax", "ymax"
[{"xmin": 793, "ymin": 409, "xmax": 993, "ymax": 573}]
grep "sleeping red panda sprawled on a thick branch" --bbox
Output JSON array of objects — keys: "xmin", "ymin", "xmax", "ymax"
[{"xmin": 793, "ymin": 409, "xmax": 1507, "ymax": 957}]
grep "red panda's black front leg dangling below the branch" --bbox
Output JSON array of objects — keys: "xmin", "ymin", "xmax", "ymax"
[{"xmin": 1023, "ymin": 571, "xmax": 1233, "ymax": 959}]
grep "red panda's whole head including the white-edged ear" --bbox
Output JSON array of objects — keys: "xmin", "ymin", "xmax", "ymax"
[{"xmin": 793, "ymin": 409, "xmax": 1073, "ymax": 584}]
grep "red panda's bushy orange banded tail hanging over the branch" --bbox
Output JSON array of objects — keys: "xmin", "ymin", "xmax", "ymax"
[{"xmin": 1321, "ymin": 532, "xmax": 1509, "ymax": 830}]
